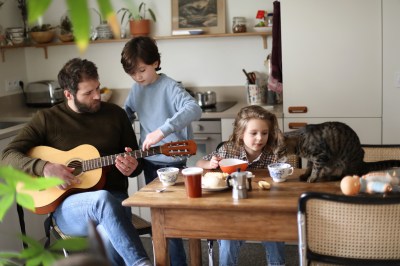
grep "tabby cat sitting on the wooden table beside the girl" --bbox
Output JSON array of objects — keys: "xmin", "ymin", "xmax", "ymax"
[{"xmin": 275, "ymin": 122, "xmax": 400, "ymax": 182}]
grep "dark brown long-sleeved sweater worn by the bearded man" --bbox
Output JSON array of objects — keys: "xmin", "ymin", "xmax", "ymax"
[{"xmin": 1, "ymin": 102, "xmax": 142, "ymax": 191}]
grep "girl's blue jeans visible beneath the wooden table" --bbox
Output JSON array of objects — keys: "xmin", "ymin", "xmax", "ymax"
[{"xmin": 218, "ymin": 240, "xmax": 285, "ymax": 266}]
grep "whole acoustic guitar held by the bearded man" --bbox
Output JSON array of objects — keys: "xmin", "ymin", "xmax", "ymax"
[{"xmin": 18, "ymin": 140, "xmax": 197, "ymax": 214}]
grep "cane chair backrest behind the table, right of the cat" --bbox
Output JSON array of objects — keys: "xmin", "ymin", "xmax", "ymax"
[{"xmin": 362, "ymin": 145, "xmax": 400, "ymax": 162}]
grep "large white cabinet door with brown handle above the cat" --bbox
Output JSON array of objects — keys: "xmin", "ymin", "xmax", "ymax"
[{"xmin": 281, "ymin": 0, "xmax": 382, "ymax": 140}]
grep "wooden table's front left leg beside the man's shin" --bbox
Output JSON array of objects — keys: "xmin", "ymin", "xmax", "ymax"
[{"xmin": 151, "ymin": 208, "xmax": 170, "ymax": 266}]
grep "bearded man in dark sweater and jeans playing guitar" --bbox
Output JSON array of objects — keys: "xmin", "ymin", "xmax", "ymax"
[{"xmin": 2, "ymin": 58, "xmax": 151, "ymax": 266}]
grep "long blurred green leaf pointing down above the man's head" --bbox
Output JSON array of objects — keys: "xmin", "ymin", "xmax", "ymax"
[{"xmin": 67, "ymin": 0, "xmax": 90, "ymax": 52}]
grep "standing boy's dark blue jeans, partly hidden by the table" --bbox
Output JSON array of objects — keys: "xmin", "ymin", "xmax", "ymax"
[{"xmin": 143, "ymin": 160, "xmax": 187, "ymax": 266}]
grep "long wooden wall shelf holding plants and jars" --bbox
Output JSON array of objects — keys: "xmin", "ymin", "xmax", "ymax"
[{"xmin": 0, "ymin": 29, "xmax": 272, "ymax": 62}]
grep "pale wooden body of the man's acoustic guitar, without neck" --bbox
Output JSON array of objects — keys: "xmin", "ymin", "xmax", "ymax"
[{"xmin": 18, "ymin": 144, "xmax": 105, "ymax": 214}]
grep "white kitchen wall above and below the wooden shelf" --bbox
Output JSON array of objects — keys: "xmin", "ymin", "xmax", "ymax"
[{"xmin": 0, "ymin": 0, "xmax": 273, "ymax": 96}]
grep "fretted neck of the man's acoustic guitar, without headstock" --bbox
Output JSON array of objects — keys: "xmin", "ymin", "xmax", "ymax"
[{"xmin": 82, "ymin": 146, "xmax": 162, "ymax": 172}]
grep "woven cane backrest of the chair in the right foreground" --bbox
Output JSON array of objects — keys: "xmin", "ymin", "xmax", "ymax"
[{"xmin": 298, "ymin": 192, "xmax": 400, "ymax": 265}]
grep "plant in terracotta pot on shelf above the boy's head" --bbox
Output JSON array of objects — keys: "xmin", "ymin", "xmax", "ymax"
[{"xmin": 117, "ymin": 2, "xmax": 157, "ymax": 37}]
